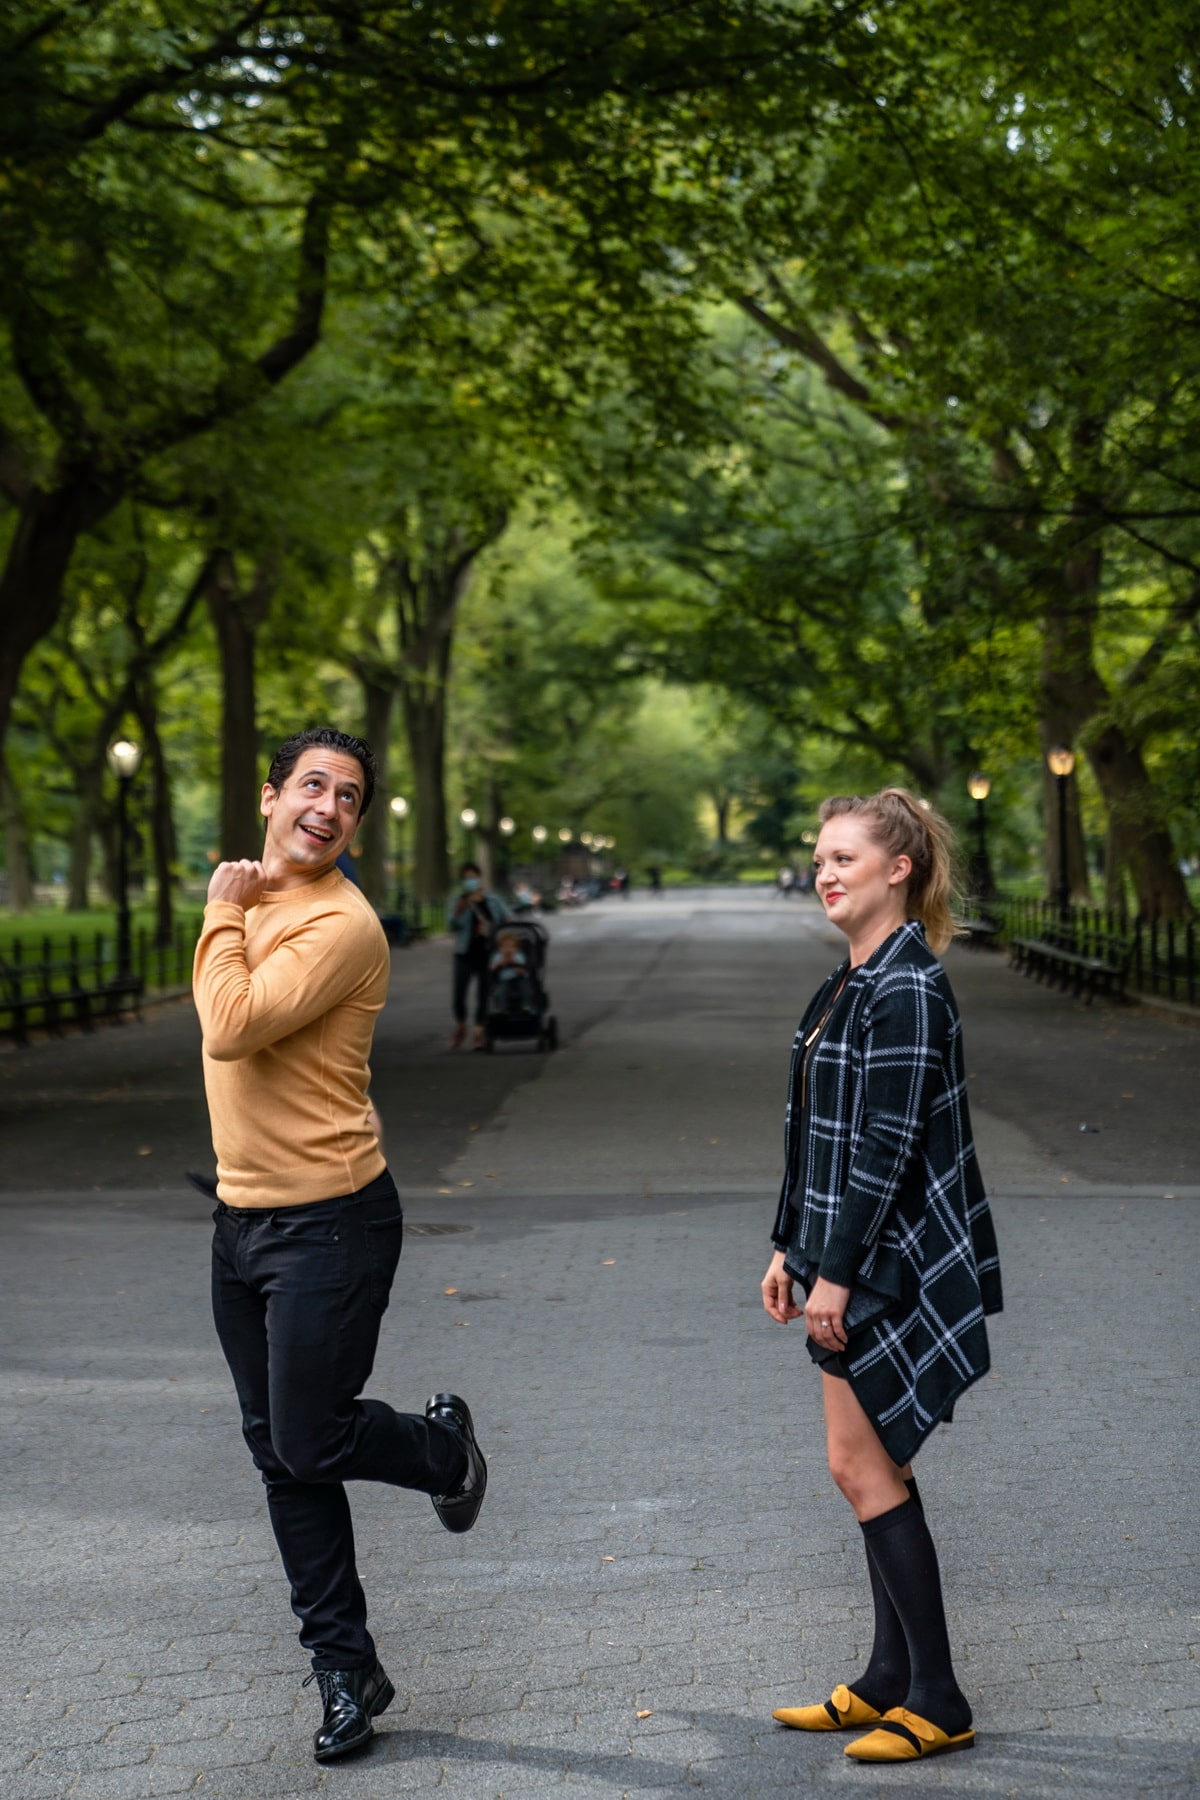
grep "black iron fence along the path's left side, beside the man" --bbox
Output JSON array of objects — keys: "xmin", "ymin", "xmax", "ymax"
[{"xmin": 0, "ymin": 918, "xmax": 200, "ymax": 1042}]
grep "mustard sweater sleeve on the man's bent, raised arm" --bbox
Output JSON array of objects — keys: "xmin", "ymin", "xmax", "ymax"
[{"xmin": 193, "ymin": 900, "xmax": 374, "ymax": 1062}]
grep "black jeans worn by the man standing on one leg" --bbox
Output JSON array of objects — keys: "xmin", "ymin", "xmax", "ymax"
[{"xmin": 212, "ymin": 1170, "xmax": 464, "ymax": 1669}]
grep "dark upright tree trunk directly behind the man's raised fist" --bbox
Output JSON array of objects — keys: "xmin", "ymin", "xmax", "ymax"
[{"xmin": 205, "ymin": 551, "xmax": 273, "ymax": 862}]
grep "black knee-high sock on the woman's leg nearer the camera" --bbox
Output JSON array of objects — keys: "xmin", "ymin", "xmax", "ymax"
[{"xmin": 862, "ymin": 1499, "xmax": 972, "ymax": 1737}]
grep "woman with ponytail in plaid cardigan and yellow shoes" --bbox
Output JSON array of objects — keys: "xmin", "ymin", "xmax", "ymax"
[{"xmin": 763, "ymin": 788, "xmax": 1002, "ymax": 1762}]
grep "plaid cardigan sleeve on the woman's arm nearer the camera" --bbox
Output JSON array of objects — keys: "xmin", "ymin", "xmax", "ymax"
[{"xmin": 820, "ymin": 968, "xmax": 948, "ymax": 1287}]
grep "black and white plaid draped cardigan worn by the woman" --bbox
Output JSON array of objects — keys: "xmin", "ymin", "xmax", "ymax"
[{"xmin": 772, "ymin": 920, "xmax": 1004, "ymax": 1465}]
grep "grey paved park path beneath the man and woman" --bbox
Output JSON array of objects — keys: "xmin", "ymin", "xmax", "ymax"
[{"xmin": 0, "ymin": 889, "xmax": 1200, "ymax": 1800}]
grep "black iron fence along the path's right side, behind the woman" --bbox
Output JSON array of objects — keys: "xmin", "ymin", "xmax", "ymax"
[{"xmin": 988, "ymin": 900, "xmax": 1200, "ymax": 1006}]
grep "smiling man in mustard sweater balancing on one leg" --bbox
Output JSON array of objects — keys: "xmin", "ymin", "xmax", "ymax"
[{"xmin": 194, "ymin": 725, "xmax": 488, "ymax": 1762}]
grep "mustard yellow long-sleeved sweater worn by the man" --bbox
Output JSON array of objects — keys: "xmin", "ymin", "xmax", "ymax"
[{"xmin": 193, "ymin": 869, "xmax": 389, "ymax": 1208}]
